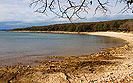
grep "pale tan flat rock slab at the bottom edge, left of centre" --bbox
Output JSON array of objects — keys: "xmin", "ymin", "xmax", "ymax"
[{"xmin": 10, "ymin": 71, "xmax": 69, "ymax": 83}]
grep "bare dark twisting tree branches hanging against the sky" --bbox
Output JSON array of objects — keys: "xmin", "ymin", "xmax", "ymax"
[{"xmin": 30, "ymin": 0, "xmax": 133, "ymax": 21}]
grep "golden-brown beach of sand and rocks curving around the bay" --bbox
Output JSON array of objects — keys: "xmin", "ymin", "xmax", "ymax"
[{"xmin": 0, "ymin": 31, "xmax": 133, "ymax": 83}]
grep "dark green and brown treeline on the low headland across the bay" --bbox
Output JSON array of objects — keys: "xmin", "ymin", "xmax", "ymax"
[{"xmin": 13, "ymin": 19, "xmax": 133, "ymax": 32}]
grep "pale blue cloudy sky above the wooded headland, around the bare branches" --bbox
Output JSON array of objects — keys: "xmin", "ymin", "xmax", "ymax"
[{"xmin": 0, "ymin": 0, "xmax": 133, "ymax": 29}]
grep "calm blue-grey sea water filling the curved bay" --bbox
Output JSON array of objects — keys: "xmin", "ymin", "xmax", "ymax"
[{"xmin": 0, "ymin": 31, "xmax": 125, "ymax": 65}]
